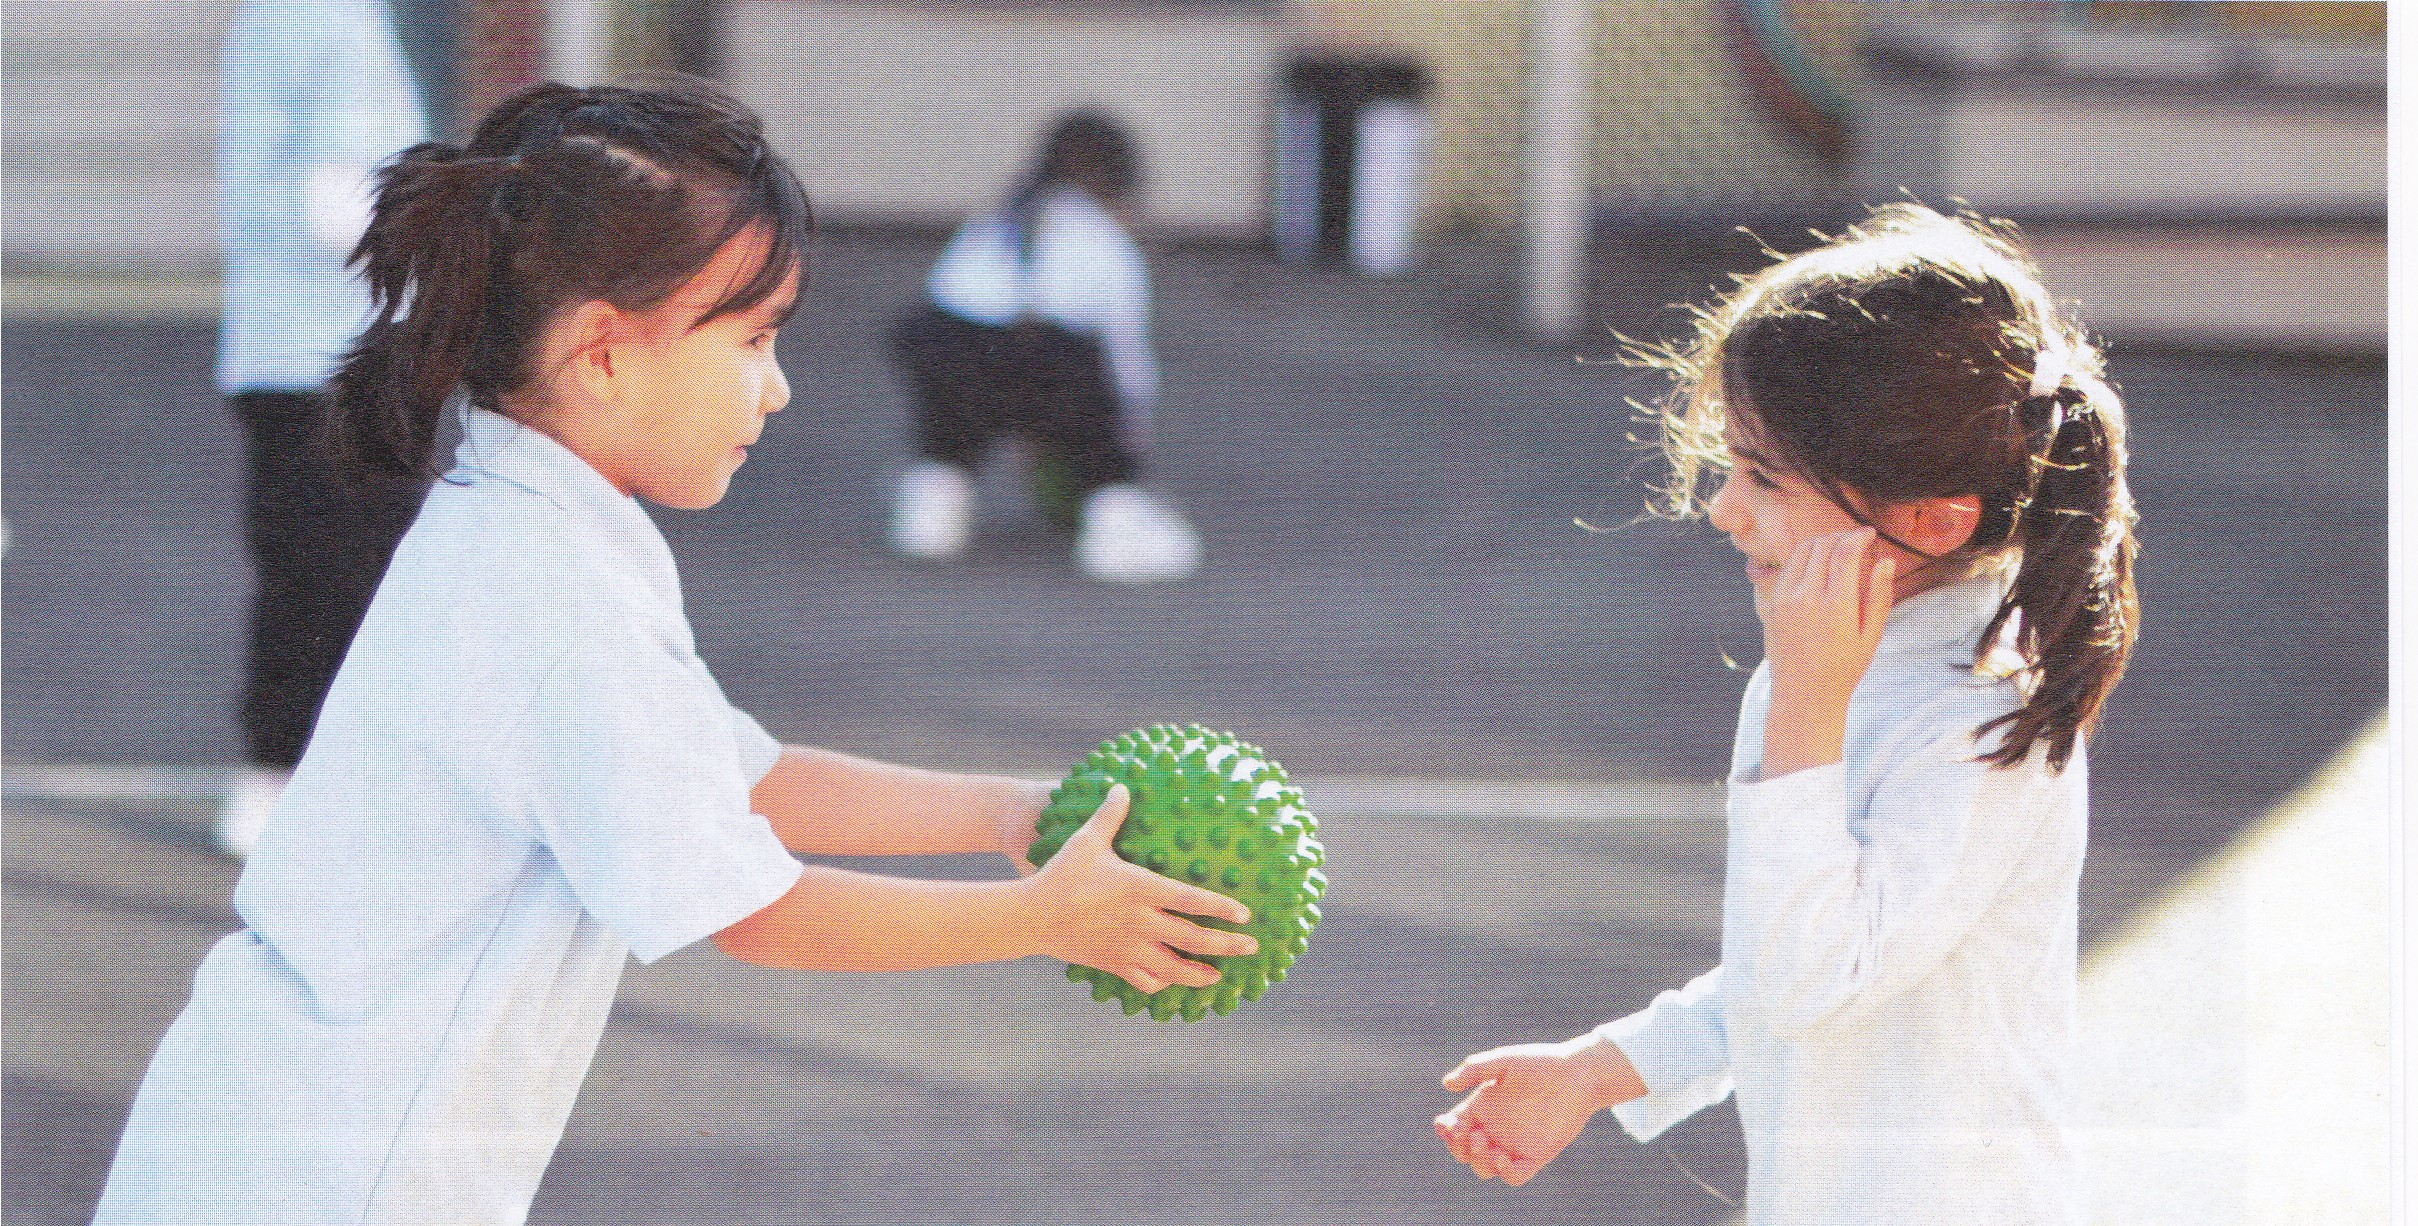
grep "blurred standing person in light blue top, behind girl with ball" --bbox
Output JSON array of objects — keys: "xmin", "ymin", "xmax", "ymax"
[{"xmin": 218, "ymin": 0, "xmax": 428, "ymax": 858}]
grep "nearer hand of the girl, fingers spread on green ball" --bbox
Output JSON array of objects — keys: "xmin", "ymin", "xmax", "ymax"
[{"xmin": 1028, "ymin": 783, "xmax": 1260, "ymax": 991}]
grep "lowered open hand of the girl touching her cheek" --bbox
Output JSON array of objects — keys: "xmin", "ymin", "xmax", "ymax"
[{"xmin": 1436, "ymin": 1035, "xmax": 1647, "ymax": 1187}]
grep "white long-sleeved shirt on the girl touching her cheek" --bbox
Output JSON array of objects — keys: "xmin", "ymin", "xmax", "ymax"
[{"xmin": 1598, "ymin": 578, "xmax": 2089, "ymax": 1226}]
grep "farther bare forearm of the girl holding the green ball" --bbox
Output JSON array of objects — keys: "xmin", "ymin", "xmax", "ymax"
[{"xmin": 747, "ymin": 745, "xmax": 1049, "ymax": 871}]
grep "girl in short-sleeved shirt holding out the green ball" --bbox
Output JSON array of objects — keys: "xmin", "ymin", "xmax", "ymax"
[{"xmin": 97, "ymin": 80, "xmax": 1253, "ymax": 1224}]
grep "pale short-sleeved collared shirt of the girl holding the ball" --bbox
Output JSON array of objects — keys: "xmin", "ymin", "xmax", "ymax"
[{"xmin": 97, "ymin": 411, "xmax": 800, "ymax": 1224}]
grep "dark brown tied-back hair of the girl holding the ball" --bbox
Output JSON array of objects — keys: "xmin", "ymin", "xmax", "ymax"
[{"xmin": 326, "ymin": 77, "xmax": 812, "ymax": 476}]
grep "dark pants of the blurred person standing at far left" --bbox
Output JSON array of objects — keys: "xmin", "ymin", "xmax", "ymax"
[{"xmin": 227, "ymin": 392, "xmax": 428, "ymax": 769}]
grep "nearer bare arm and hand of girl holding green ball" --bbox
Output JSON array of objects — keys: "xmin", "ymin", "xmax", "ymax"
[{"xmin": 713, "ymin": 786, "xmax": 1257, "ymax": 991}]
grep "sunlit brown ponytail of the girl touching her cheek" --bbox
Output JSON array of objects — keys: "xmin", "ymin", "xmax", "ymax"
[{"xmin": 1976, "ymin": 375, "xmax": 2140, "ymax": 769}]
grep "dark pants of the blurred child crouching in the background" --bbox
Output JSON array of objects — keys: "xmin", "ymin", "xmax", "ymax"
[{"xmin": 890, "ymin": 307, "xmax": 1141, "ymax": 498}]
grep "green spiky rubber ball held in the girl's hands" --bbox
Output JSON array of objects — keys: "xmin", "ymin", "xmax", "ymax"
[{"xmin": 1025, "ymin": 723, "xmax": 1327, "ymax": 1020}]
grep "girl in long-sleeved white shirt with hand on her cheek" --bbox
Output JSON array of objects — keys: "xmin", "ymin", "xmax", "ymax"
[{"xmin": 1436, "ymin": 203, "xmax": 2140, "ymax": 1224}]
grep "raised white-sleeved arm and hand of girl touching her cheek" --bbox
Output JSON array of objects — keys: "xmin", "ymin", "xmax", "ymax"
[{"xmin": 1722, "ymin": 530, "xmax": 2084, "ymax": 1037}]
